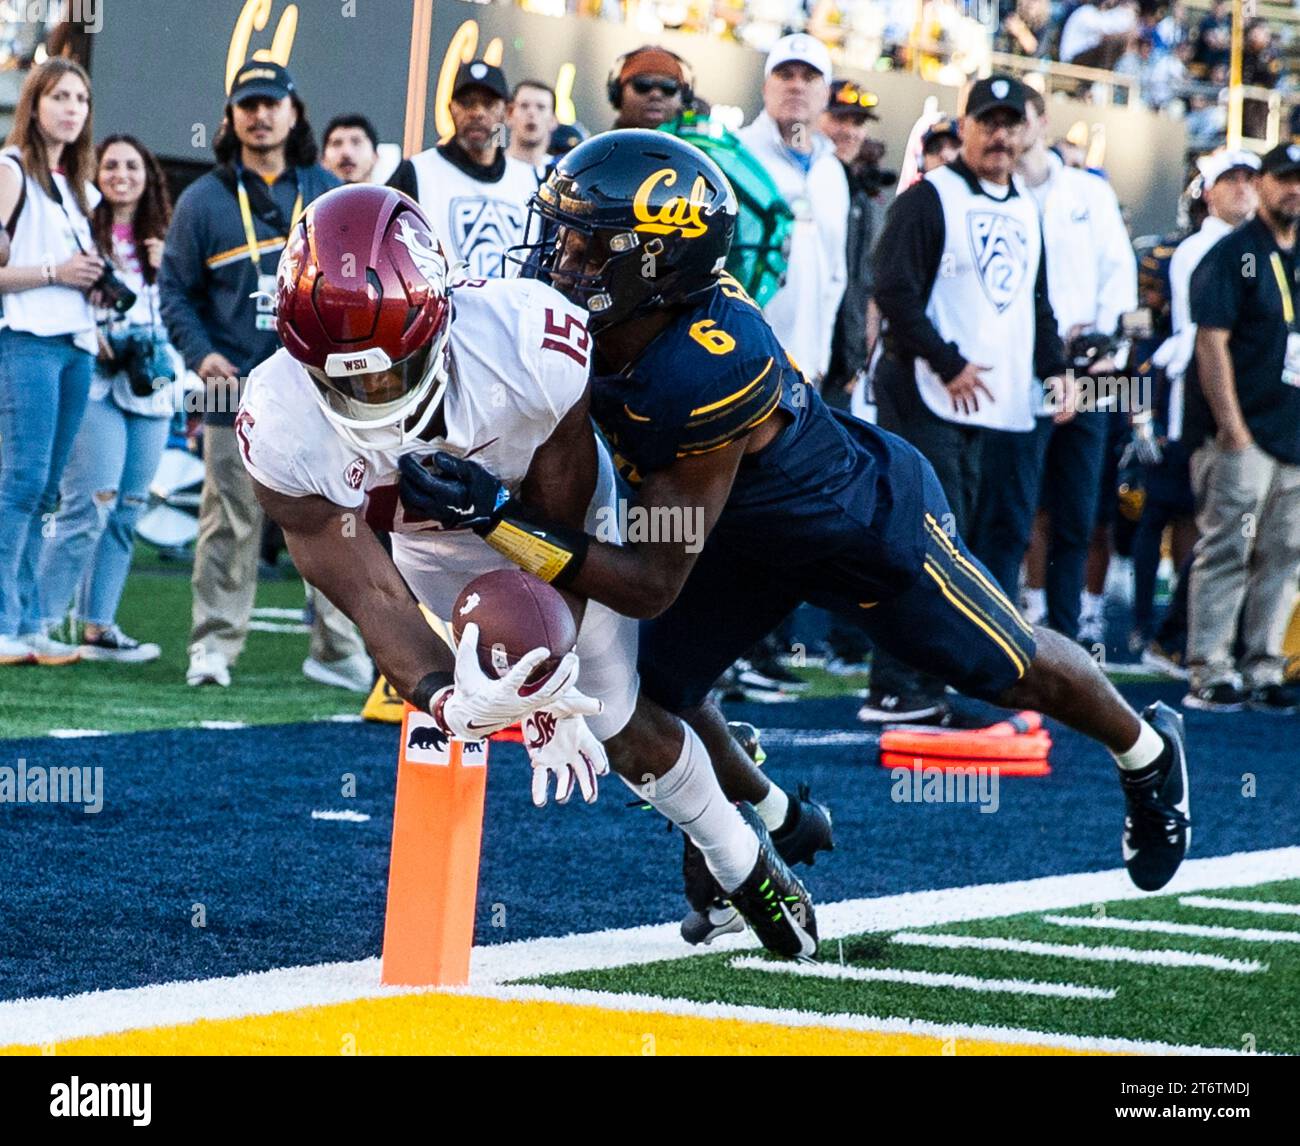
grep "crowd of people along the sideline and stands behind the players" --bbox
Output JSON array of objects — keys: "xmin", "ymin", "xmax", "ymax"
[{"xmin": 0, "ymin": 15, "xmax": 1300, "ymax": 722}]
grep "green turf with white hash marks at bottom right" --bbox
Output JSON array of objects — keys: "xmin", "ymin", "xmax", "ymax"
[{"xmin": 529, "ymin": 880, "xmax": 1300, "ymax": 1054}]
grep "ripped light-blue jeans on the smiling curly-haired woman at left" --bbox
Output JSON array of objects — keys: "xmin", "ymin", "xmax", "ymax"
[{"xmin": 36, "ymin": 395, "xmax": 169, "ymax": 628}]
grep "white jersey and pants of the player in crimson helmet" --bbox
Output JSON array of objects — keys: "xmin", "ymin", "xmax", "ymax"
[{"xmin": 235, "ymin": 278, "xmax": 638, "ymax": 739}]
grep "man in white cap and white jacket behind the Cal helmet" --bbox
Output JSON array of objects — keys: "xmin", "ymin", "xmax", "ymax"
[{"xmin": 737, "ymin": 34, "xmax": 849, "ymax": 386}]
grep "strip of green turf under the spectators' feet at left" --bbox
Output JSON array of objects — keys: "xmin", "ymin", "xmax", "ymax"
[{"xmin": 0, "ymin": 546, "xmax": 364, "ymax": 738}]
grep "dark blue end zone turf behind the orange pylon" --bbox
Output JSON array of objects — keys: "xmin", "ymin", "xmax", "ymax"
[{"xmin": 0, "ymin": 685, "xmax": 1300, "ymax": 998}]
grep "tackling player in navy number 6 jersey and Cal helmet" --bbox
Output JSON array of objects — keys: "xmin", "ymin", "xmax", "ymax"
[{"xmin": 403, "ymin": 130, "xmax": 1190, "ymax": 941}]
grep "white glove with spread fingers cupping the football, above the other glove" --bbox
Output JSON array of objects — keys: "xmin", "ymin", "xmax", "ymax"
[{"xmin": 429, "ymin": 621, "xmax": 605, "ymax": 741}]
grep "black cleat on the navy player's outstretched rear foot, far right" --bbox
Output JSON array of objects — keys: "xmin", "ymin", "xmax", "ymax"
[{"xmin": 1119, "ymin": 702, "xmax": 1192, "ymax": 891}]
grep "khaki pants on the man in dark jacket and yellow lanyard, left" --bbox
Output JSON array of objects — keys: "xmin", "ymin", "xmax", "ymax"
[{"xmin": 190, "ymin": 422, "xmax": 364, "ymax": 664}]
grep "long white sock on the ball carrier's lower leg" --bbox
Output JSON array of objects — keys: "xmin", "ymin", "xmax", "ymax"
[{"xmin": 624, "ymin": 725, "xmax": 758, "ymax": 891}]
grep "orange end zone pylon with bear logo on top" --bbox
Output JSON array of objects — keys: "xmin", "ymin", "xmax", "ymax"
[{"xmin": 381, "ymin": 704, "xmax": 488, "ymax": 986}]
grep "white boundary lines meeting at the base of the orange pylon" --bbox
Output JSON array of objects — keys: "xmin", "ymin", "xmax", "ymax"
[{"xmin": 0, "ymin": 847, "xmax": 1300, "ymax": 1052}]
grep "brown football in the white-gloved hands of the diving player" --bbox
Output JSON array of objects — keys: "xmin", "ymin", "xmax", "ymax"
[{"xmin": 451, "ymin": 569, "xmax": 577, "ymax": 695}]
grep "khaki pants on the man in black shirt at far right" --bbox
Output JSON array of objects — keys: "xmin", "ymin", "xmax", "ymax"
[{"xmin": 1187, "ymin": 442, "xmax": 1300, "ymax": 689}]
